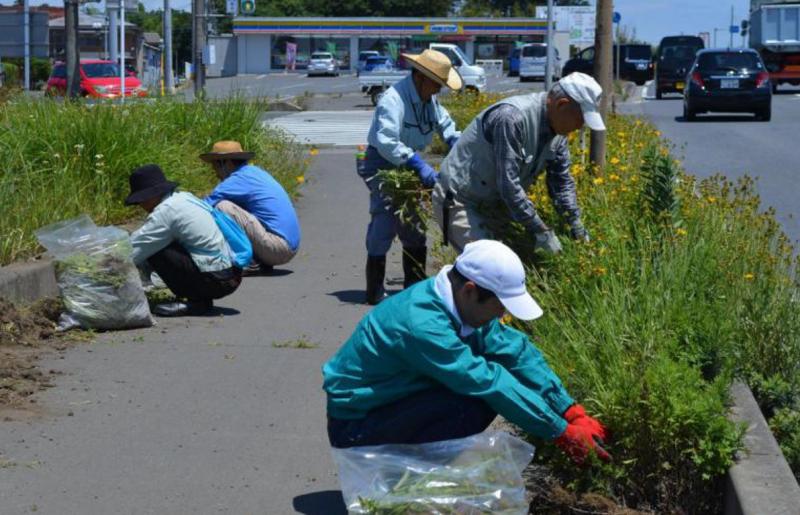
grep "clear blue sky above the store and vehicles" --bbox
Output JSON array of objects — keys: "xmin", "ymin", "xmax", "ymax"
[{"xmin": 7, "ymin": 0, "xmax": 750, "ymax": 46}]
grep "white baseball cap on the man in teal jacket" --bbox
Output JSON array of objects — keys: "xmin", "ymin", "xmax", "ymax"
[{"xmin": 455, "ymin": 240, "xmax": 543, "ymax": 320}]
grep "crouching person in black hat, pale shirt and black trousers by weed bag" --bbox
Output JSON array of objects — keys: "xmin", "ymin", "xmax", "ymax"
[{"xmin": 125, "ymin": 164, "xmax": 242, "ymax": 316}]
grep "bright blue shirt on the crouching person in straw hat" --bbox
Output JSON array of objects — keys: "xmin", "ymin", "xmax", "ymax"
[{"xmin": 206, "ymin": 164, "xmax": 300, "ymax": 251}]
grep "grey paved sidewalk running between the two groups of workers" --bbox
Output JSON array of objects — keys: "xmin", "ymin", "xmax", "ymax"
[{"xmin": 0, "ymin": 148, "xmax": 412, "ymax": 515}]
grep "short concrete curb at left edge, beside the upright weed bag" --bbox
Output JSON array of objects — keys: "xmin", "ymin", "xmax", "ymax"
[{"xmin": 0, "ymin": 260, "xmax": 58, "ymax": 303}]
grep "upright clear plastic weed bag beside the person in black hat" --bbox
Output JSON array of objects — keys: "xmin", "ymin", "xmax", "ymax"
[{"xmin": 36, "ymin": 215, "xmax": 153, "ymax": 330}]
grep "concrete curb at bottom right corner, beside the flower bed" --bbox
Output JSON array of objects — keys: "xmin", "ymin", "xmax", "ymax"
[{"xmin": 723, "ymin": 381, "xmax": 800, "ymax": 515}]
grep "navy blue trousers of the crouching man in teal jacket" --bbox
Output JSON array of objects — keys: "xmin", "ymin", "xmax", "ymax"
[{"xmin": 328, "ymin": 387, "xmax": 497, "ymax": 448}]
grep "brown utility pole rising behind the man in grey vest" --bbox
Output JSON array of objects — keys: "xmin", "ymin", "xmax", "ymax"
[{"xmin": 589, "ymin": 0, "xmax": 614, "ymax": 168}]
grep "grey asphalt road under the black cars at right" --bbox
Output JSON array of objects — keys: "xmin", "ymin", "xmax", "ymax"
[{"xmin": 620, "ymin": 83, "xmax": 800, "ymax": 245}]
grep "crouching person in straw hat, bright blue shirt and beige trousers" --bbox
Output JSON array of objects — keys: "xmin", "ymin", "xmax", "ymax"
[{"xmin": 200, "ymin": 141, "xmax": 300, "ymax": 275}]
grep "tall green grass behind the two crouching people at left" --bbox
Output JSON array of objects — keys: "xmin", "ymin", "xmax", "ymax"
[{"xmin": 0, "ymin": 97, "xmax": 305, "ymax": 264}]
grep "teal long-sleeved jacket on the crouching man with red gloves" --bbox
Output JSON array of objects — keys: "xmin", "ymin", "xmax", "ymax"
[{"xmin": 322, "ymin": 270, "xmax": 574, "ymax": 439}]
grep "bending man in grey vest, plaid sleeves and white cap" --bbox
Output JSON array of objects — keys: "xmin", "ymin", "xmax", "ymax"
[{"xmin": 433, "ymin": 73, "xmax": 605, "ymax": 254}]
